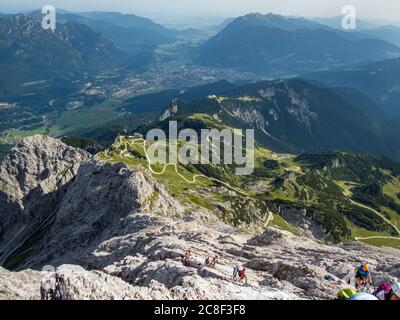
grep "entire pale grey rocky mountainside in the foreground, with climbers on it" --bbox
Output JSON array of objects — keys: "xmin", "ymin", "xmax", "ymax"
[{"xmin": 0, "ymin": 136, "xmax": 400, "ymax": 300}]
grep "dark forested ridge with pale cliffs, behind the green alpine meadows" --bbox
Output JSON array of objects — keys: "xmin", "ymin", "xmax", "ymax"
[{"xmin": 156, "ymin": 79, "xmax": 393, "ymax": 154}]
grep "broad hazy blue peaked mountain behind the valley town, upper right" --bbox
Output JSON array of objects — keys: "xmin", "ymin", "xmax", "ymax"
[{"xmin": 199, "ymin": 13, "xmax": 400, "ymax": 77}]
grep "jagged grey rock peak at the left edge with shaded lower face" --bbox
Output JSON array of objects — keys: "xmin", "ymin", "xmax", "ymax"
[{"xmin": 0, "ymin": 135, "xmax": 91, "ymax": 265}]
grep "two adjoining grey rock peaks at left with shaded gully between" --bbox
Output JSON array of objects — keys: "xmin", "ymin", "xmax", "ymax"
[{"xmin": 0, "ymin": 136, "xmax": 183, "ymax": 269}]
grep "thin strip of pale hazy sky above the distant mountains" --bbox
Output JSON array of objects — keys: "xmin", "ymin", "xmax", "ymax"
[{"xmin": 0, "ymin": 0, "xmax": 400, "ymax": 21}]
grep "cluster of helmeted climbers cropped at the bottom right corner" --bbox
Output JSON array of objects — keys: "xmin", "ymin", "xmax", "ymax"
[{"xmin": 337, "ymin": 262, "xmax": 400, "ymax": 300}]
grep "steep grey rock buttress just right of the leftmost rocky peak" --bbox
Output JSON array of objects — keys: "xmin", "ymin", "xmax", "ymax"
[{"xmin": 21, "ymin": 160, "xmax": 183, "ymax": 266}]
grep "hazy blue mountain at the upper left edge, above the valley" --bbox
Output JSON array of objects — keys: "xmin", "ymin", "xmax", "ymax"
[{"xmin": 0, "ymin": 15, "xmax": 128, "ymax": 98}]
